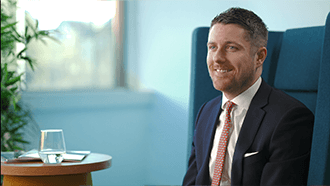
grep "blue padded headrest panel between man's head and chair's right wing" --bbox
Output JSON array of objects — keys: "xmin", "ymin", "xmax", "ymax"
[{"xmin": 275, "ymin": 26, "xmax": 324, "ymax": 92}]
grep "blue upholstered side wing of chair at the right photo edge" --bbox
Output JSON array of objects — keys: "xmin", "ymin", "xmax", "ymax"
[{"xmin": 308, "ymin": 13, "xmax": 330, "ymax": 185}]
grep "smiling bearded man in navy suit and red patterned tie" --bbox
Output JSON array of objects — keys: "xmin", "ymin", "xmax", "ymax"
[{"xmin": 183, "ymin": 8, "xmax": 314, "ymax": 185}]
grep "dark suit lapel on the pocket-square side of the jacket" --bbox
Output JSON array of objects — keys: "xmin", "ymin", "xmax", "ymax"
[{"xmin": 231, "ymin": 81, "xmax": 271, "ymax": 185}]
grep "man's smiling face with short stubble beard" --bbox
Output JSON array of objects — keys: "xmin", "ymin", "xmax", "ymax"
[{"xmin": 207, "ymin": 23, "xmax": 266, "ymax": 99}]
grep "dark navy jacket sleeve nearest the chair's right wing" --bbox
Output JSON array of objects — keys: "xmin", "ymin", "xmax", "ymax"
[{"xmin": 260, "ymin": 107, "xmax": 314, "ymax": 185}]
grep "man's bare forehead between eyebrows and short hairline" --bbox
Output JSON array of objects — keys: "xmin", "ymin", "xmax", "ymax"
[{"xmin": 208, "ymin": 23, "xmax": 250, "ymax": 45}]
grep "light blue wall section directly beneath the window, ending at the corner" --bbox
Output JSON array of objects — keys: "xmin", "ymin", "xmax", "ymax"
[{"xmin": 23, "ymin": 90, "xmax": 154, "ymax": 186}]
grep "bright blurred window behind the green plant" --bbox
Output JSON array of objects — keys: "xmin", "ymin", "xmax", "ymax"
[{"xmin": 18, "ymin": 0, "xmax": 125, "ymax": 91}]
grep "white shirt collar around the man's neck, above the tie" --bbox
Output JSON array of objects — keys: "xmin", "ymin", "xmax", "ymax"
[{"xmin": 221, "ymin": 77, "xmax": 261, "ymax": 110}]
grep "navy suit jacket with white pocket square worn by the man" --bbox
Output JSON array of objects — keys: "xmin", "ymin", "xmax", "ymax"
[{"xmin": 183, "ymin": 81, "xmax": 314, "ymax": 185}]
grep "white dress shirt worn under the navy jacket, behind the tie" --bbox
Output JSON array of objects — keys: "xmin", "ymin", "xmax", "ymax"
[{"xmin": 209, "ymin": 77, "xmax": 261, "ymax": 186}]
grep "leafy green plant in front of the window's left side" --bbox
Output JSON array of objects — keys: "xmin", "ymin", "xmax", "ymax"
[{"xmin": 1, "ymin": 0, "xmax": 51, "ymax": 151}]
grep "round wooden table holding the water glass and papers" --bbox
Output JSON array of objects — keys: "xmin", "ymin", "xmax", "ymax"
[{"xmin": 1, "ymin": 153, "xmax": 112, "ymax": 186}]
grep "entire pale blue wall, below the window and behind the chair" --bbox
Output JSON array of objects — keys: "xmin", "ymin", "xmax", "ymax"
[{"xmin": 23, "ymin": 0, "xmax": 330, "ymax": 186}]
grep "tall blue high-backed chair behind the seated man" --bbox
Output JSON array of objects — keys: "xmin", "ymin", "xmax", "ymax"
[{"xmin": 188, "ymin": 13, "xmax": 330, "ymax": 185}]
